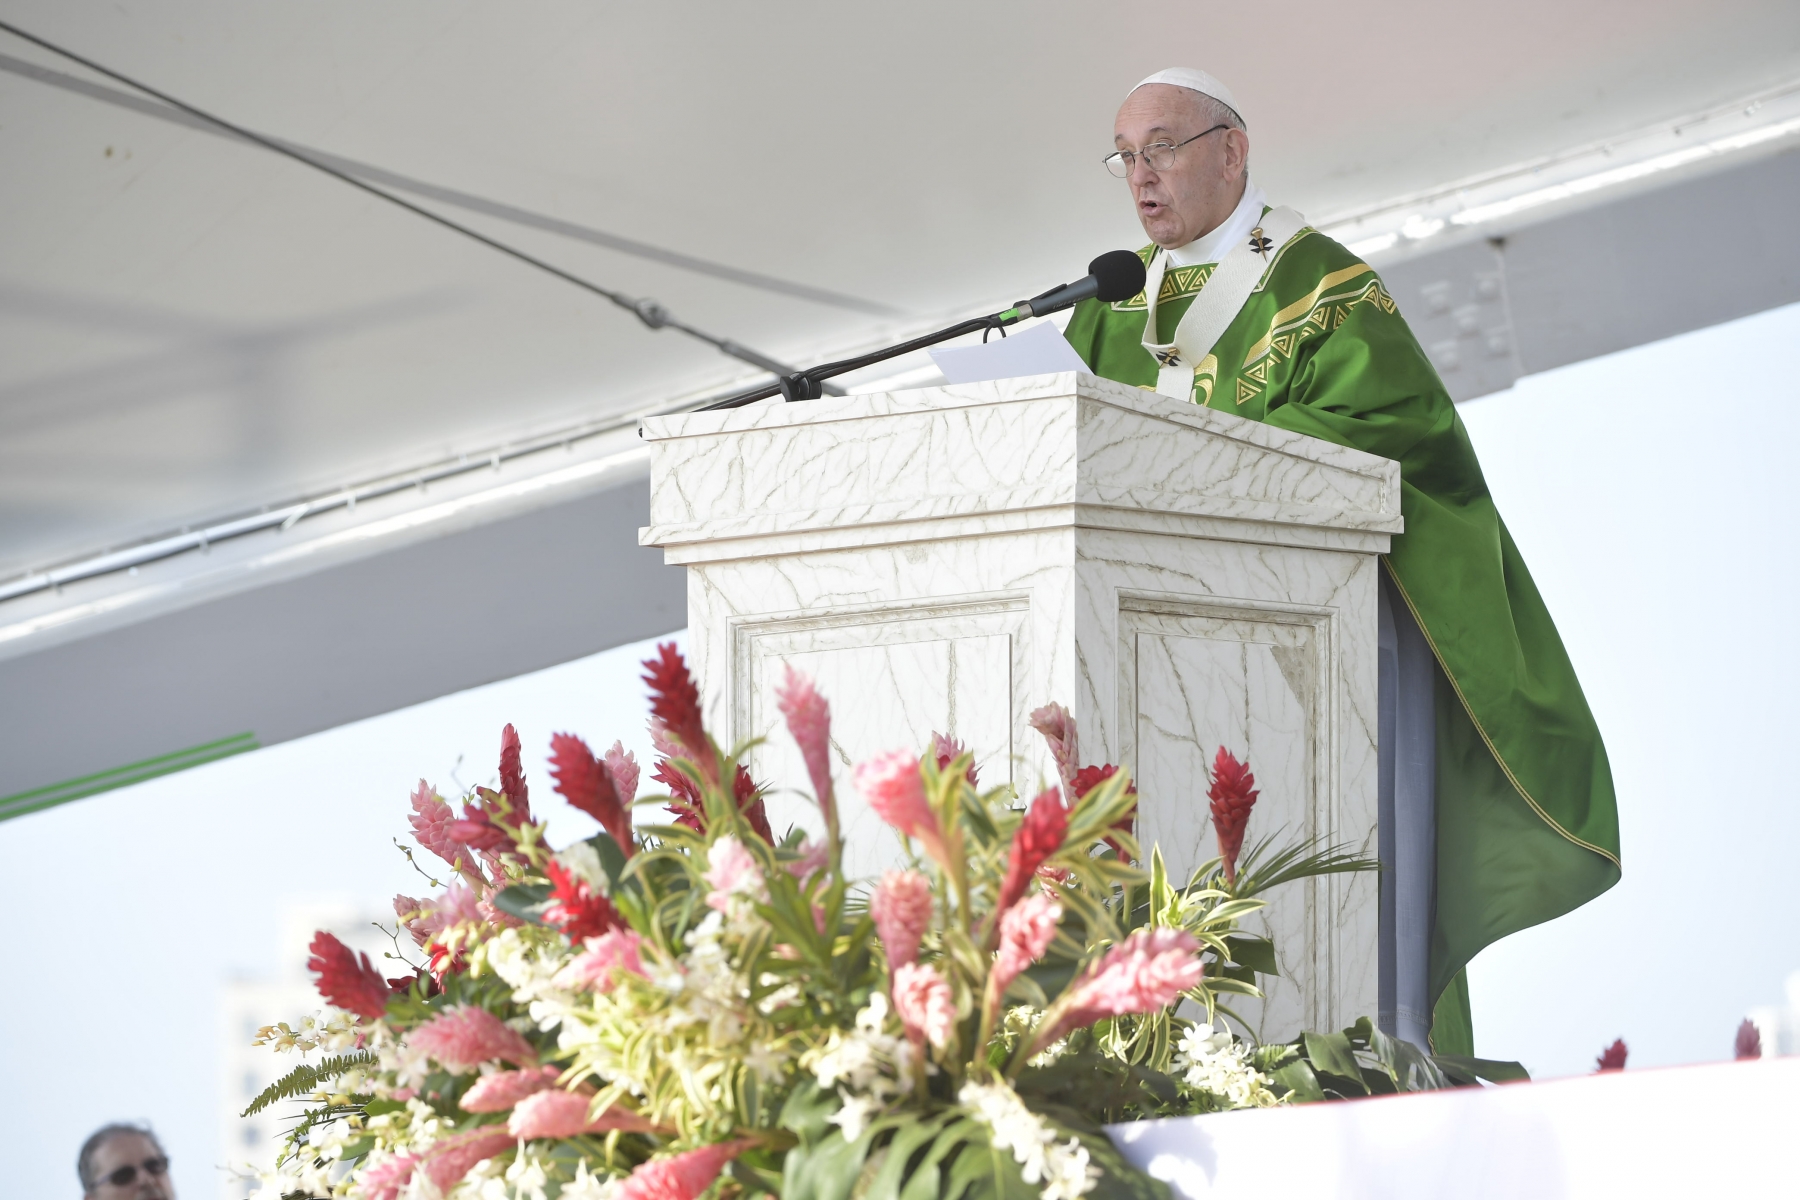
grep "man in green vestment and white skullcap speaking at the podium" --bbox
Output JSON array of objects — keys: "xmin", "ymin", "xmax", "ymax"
[{"xmin": 1067, "ymin": 68, "xmax": 1618, "ymax": 1054}]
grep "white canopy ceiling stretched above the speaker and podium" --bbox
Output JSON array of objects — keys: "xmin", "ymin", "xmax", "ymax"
[{"xmin": 0, "ymin": 0, "xmax": 1800, "ymax": 578}]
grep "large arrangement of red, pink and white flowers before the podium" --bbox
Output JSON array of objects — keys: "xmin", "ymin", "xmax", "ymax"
[{"xmin": 247, "ymin": 646, "xmax": 1519, "ymax": 1200}]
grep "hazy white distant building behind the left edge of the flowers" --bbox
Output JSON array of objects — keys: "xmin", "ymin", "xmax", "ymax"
[{"xmin": 218, "ymin": 900, "xmax": 410, "ymax": 1200}]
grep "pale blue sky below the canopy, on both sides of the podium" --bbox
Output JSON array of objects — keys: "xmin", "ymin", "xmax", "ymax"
[{"xmin": 0, "ymin": 298, "xmax": 1800, "ymax": 1200}]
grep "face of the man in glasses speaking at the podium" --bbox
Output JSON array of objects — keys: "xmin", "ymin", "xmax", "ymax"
[{"xmin": 1112, "ymin": 83, "xmax": 1249, "ymax": 248}]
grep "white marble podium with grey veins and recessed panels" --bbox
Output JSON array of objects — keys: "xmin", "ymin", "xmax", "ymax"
[{"xmin": 641, "ymin": 372, "xmax": 1400, "ymax": 1036}]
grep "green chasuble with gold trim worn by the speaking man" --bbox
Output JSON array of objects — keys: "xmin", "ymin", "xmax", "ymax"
[{"xmin": 1067, "ymin": 228, "xmax": 1620, "ymax": 1054}]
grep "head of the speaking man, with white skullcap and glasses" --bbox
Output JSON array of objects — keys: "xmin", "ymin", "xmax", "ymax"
[{"xmin": 1107, "ymin": 68, "xmax": 1249, "ymax": 250}]
